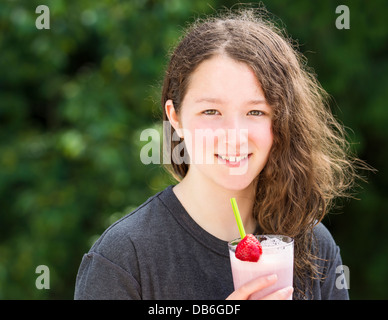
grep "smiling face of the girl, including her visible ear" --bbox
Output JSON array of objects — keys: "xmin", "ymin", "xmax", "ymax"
[{"xmin": 166, "ymin": 56, "xmax": 273, "ymax": 190}]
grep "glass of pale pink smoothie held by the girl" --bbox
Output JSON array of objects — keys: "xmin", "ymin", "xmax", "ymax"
[{"xmin": 229, "ymin": 235, "xmax": 294, "ymax": 300}]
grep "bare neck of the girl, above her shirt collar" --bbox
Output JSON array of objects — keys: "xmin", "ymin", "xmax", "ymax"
[{"xmin": 173, "ymin": 170, "xmax": 257, "ymax": 241}]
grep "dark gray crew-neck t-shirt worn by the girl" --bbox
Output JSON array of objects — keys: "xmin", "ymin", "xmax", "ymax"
[{"xmin": 74, "ymin": 186, "xmax": 348, "ymax": 300}]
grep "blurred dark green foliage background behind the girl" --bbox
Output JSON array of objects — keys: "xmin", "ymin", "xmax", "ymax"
[{"xmin": 0, "ymin": 0, "xmax": 388, "ymax": 299}]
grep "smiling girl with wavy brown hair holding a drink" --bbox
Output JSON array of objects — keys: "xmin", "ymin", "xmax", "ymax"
[{"xmin": 75, "ymin": 10, "xmax": 364, "ymax": 300}]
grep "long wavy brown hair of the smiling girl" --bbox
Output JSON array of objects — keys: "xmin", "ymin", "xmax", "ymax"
[{"xmin": 161, "ymin": 9, "xmax": 366, "ymax": 297}]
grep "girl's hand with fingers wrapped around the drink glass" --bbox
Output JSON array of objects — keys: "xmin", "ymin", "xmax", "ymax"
[{"xmin": 226, "ymin": 274, "xmax": 294, "ymax": 300}]
